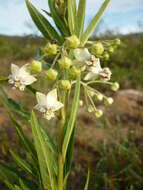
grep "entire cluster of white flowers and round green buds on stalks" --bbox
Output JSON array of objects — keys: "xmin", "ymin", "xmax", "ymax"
[{"xmin": 9, "ymin": 35, "xmax": 120, "ymax": 120}]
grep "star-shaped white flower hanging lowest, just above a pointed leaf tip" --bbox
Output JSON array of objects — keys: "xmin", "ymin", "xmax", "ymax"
[{"xmin": 35, "ymin": 89, "xmax": 64, "ymax": 120}]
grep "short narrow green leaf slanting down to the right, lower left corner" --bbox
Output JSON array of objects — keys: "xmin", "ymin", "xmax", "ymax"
[{"xmin": 10, "ymin": 150, "xmax": 34, "ymax": 175}]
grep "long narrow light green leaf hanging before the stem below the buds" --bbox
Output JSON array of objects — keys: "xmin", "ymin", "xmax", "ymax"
[{"xmin": 62, "ymin": 77, "xmax": 80, "ymax": 159}]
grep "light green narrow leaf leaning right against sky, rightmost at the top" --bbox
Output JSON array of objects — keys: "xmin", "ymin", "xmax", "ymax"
[{"xmin": 81, "ymin": 0, "xmax": 110, "ymax": 46}]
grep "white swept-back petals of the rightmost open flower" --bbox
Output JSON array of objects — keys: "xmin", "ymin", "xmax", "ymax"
[{"xmin": 84, "ymin": 59, "xmax": 103, "ymax": 80}]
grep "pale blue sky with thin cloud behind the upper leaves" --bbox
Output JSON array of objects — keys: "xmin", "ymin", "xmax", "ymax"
[{"xmin": 0, "ymin": 0, "xmax": 143, "ymax": 35}]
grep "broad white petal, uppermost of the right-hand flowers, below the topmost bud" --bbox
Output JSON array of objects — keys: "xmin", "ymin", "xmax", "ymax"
[{"xmin": 74, "ymin": 48, "xmax": 91, "ymax": 62}]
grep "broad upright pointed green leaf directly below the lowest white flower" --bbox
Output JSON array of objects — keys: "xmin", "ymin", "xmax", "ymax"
[{"xmin": 31, "ymin": 112, "xmax": 56, "ymax": 190}]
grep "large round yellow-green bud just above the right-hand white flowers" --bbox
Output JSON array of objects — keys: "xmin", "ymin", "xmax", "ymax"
[{"xmin": 91, "ymin": 42, "xmax": 104, "ymax": 56}]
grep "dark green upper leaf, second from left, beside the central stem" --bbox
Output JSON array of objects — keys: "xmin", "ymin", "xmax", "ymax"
[{"xmin": 48, "ymin": 0, "xmax": 69, "ymax": 37}]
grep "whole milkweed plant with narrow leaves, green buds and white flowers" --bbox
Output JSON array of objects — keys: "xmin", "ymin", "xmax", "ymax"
[{"xmin": 0, "ymin": 0, "xmax": 120, "ymax": 190}]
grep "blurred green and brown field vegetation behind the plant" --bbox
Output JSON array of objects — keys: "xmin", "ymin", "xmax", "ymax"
[{"xmin": 0, "ymin": 33, "xmax": 143, "ymax": 190}]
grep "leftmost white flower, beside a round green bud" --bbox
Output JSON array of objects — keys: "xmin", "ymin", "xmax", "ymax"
[{"xmin": 8, "ymin": 64, "xmax": 37, "ymax": 91}]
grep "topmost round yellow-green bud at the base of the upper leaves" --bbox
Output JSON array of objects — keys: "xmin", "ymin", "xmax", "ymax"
[{"xmin": 66, "ymin": 35, "xmax": 80, "ymax": 49}]
